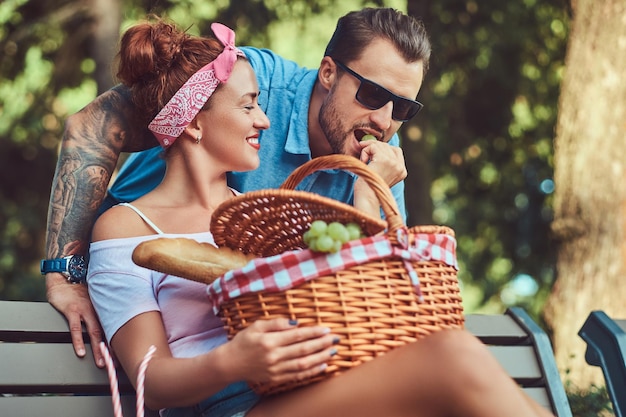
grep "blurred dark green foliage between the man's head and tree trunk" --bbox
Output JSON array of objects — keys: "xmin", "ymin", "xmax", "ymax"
[{"xmin": 412, "ymin": 0, "xmax": 569, "ymax": 312}]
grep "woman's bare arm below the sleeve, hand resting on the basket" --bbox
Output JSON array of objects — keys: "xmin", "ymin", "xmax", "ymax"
[{"xmin": 111, "ymin": 311, "xmax": 335, "ymax": 409}]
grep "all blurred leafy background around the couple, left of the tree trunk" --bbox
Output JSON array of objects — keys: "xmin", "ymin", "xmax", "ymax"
[{"xmin": 0, "ymin": 0, "xmax": 569, "ymax": 320}]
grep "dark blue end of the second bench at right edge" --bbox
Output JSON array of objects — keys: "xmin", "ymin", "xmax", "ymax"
[{"xmin": 578, "ymin": 311, "xmax": 626, "ymax": 417}]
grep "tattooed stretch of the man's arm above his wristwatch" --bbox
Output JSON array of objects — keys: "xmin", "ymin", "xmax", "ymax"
[{"xmin": 46, "ymin": 86, "xmax": 157, "ymax": 258}]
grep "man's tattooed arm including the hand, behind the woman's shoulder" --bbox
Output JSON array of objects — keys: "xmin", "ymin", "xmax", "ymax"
[{"xmin": 46, "ymin": 86, "xmax": 156, "ymax": 367}]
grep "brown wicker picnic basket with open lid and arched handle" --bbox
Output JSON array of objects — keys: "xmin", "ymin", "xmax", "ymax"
[{"xmin": 211, "ymin": 155, "xmax": 464, "ymax": 395}]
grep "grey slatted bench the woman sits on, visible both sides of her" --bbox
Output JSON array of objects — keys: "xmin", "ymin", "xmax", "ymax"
[{"xmin": 0, "ymin": 301, "xmax": 572, "ymax": 417}]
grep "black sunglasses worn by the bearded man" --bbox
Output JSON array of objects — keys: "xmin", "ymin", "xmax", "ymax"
[{"xmin": 334, "ymin": 59, "xmax": 424, "ymax": 122}]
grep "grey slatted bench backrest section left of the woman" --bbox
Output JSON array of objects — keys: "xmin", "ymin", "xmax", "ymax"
[{"xmin": 0, "ymin": 301, "xmax": 145, "ymax": 417}]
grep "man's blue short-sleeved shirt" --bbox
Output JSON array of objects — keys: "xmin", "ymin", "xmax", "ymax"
[{"xmin": 101, "ymin": 47, "xmax": 406, "ymax": 222}]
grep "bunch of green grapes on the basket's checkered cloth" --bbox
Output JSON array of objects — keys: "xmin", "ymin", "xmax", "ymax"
[{"xmin": 302, "ymin": 220, "xmax": 364, "ymax": 253}]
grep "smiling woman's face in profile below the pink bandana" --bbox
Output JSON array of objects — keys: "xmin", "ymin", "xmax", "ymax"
[{"xmin": 198, "ymin": 59, "xmax": 270, "ymax": 171}]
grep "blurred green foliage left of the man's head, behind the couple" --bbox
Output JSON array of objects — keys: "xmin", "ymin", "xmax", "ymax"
[{"xmin": 0, "ymin": 0, "xmax": 394, "ymax": 300}]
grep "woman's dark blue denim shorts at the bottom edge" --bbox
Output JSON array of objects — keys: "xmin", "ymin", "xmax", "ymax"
[{"xmin": 161, "ymin": 382, "xmax": 260, "ymax": 417}]
